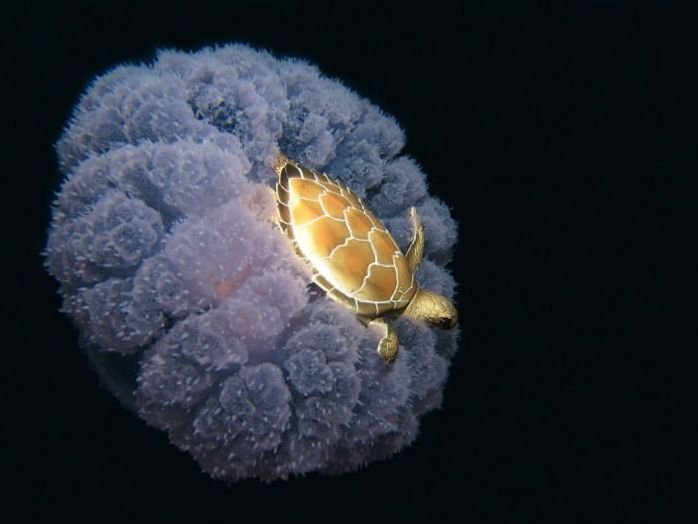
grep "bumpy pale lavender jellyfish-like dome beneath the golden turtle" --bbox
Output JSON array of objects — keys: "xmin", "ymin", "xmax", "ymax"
[{"xmin": 45, "ymin": 45, "xmax": 458, "ymax": 481}]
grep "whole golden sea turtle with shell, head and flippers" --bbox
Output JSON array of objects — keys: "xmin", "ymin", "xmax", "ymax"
[{"xmin": 273, "ymin": 154, "xmax": 457, "ymax": 362}]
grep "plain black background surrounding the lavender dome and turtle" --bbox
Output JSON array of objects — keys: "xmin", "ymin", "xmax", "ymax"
[{"xmin": 0, "ymin": 1, "xmax": 698, "ymax": 522}]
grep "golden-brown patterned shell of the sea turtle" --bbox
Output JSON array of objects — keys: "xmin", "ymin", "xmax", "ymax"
[{"xmin": 276, "ymin": 158, "xmax": 417, "ymax": 317}]
